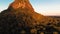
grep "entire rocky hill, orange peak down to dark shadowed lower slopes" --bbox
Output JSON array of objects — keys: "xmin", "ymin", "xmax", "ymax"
[{"xmin": 0, "ymin": 0, "xmax": 60, "ymax": 34}]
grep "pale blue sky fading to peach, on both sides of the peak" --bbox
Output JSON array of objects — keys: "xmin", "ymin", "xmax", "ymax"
[{"xmin": 0, "ymin": 0, "xmax": 60, "ymax": 16}]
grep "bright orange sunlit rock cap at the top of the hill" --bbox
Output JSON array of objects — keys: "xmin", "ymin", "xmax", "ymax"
[{"xmin": 10, "ymin": 0, "xmax": 34, "ymax": 11}]
